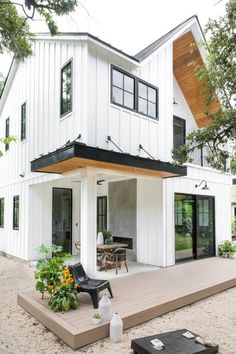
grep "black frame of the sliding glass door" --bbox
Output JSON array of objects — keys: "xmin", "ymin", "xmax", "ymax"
[{"xmin": 174, "ymin": 193, "xmax": 216, "ymax": 263}]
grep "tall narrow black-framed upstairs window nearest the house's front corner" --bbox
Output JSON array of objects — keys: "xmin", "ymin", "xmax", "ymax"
[{"xmin": 61, "ymin": 61, "xmax": 72, "ymax": 115}]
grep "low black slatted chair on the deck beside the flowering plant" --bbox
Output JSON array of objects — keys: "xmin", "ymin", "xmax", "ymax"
[{"xmin": 69, "ymin": 263, "xmax": 113, "ymax": 309}]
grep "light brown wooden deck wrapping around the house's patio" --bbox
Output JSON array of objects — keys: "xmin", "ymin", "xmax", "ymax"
[{"xmin": 18, "ymin": 257, "xmax": 236, "ymax": 349}]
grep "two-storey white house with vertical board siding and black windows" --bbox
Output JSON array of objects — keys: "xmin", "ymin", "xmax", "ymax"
[{"xmin": 0, "ymin": 16, "xmax": 231, "ymax": 274}]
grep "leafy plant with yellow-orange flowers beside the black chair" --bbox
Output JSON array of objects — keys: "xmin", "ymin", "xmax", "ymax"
[{"xmin": 48, "ymin": 268, "xmax": 79, "ymax": 312}]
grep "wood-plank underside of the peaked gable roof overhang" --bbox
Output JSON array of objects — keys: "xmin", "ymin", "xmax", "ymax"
[{"xmin": 173, "ymin": 32, "xmax": 220, "ymax": 128}]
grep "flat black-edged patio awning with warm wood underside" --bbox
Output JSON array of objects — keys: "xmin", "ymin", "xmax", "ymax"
[{"xmin": 31, "ymin": 142, "xmax": 187, "ymax": 178}]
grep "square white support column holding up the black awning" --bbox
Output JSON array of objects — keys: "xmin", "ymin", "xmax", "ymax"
[{"xmin": 80, "ymin": 168, "xmax": 97, "ymax": 276}]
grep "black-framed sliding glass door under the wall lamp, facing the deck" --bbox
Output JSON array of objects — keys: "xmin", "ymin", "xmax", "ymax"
[{"xmin": 175, "ymin": 194, "xmax": 215, "ymax": 261}]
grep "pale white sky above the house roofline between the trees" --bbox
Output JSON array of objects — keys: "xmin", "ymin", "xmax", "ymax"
[{"xmin": 0, "ymin": 0, "xmax": 226, "ymax": 76}]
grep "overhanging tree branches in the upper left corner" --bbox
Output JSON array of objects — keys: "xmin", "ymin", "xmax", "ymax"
[{"xmin": 0, "ymin": 0, "xmax": 77, "ymax": 60}]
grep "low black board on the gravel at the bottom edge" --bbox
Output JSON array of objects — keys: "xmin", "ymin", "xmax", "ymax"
[{"xmin": 131, "ymin": 329, "xmax": 219, "ymax": 354}]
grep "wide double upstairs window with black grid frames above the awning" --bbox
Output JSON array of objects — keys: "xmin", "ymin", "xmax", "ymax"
[{"xmin": 111, "ymin": 66, "xmax": 158, "ymax": 119}]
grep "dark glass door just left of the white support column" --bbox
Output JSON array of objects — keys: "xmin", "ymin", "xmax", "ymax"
[{"xmin": 52, "ymin": 188, "xmax": 72, "ymax": 252}]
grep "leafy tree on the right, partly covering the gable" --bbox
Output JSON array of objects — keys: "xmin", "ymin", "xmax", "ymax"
[{"xmin": 172, "ymin": 0, "xmax": 236, "ymax": 173}]
